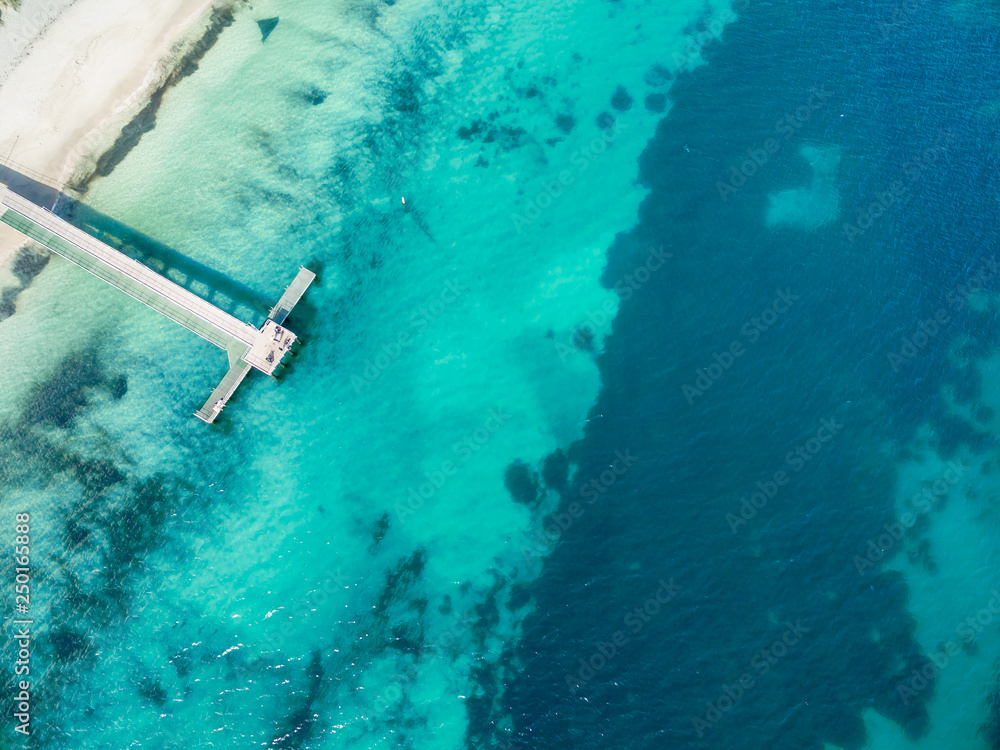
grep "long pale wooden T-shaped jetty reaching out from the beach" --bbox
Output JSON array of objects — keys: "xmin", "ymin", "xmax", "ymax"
[{"xmin": 0, "ymin": 184, "xmax": 316, "ymax": 423}]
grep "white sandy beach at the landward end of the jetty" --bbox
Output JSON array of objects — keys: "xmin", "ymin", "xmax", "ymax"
[{"xmin": 0, "ymin": 0, "xmax": 225, "ymax": 265}]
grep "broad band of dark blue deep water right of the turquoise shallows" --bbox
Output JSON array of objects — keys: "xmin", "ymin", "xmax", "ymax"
[{"xmin": 508, "ymin": 2, "xmax": 1000, "ymax": 750}]
